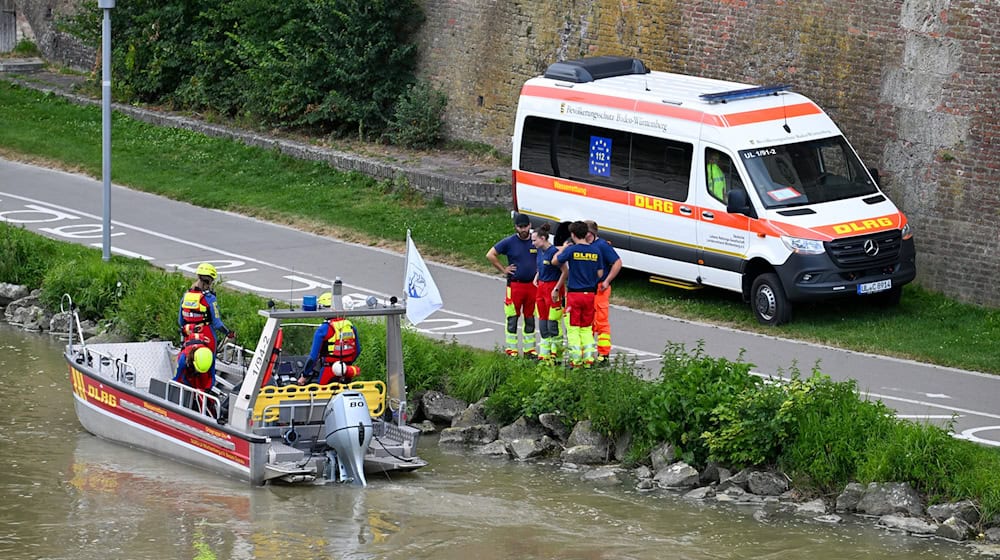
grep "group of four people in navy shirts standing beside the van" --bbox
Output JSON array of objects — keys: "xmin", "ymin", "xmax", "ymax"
[{"xmin": 486, "ymin": 214, "xmax": 622, "ymax": 367}]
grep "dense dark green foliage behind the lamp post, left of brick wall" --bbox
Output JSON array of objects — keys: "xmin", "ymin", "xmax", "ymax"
[{"xmin": 65, "ymin": 0, "xmax": 423, "ymax": 137}]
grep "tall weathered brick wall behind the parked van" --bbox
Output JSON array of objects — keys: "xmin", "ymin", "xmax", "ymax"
[{"xmin": 420, "ymin": 0, "xmax": 1000, "ymax": 306}]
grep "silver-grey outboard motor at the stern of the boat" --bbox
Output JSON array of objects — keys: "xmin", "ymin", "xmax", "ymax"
[{"xmin": 323, "ymin": 391, "xmax": 372, "ymax": 487}]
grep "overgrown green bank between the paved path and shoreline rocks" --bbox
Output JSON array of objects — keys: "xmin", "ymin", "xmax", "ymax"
[{"xmin": 0, "ymin": 222, "xmax": 1000, "ymax": 520}]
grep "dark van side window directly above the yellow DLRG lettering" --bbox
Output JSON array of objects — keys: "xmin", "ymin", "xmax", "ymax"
[{"xmin": 629, "ymin": 134, "xmax": 694, "ymax": 202}]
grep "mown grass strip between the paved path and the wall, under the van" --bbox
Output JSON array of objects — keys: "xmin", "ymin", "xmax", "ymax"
[{"xmin": 0, "ymin": 81, "xmax": 1000, "ymax": 373}]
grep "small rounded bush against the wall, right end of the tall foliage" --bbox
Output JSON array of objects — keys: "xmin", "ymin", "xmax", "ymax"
[{"xmin": 386, "ymin": 81, "xmax": 448, "ymax": 148}]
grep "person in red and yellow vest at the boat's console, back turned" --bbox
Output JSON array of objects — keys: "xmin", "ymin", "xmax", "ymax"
[{"xmin": 298, "ymin": 298, "xmax": 361, "ymax": 385}]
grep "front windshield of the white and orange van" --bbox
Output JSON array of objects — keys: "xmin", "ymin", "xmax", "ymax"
[{"xmin": 740, "ymin": 136, "xmax": 878, "ymax": 208}]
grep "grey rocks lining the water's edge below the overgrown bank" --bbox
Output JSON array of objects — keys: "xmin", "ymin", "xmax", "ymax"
[{"xmin": 0, "ymin": 282, "xmax": 1000, "ymax": 555}]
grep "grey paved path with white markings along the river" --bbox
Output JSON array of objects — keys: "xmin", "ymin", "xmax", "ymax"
[{"xmin": 0, "ymin": 160, "xmax": 1000, "ymax": 445}]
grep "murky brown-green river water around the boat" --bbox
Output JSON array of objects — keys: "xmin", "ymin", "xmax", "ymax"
[{"xmin": 0, "ymin": 323, "xmax": 974, "ymax": 560}]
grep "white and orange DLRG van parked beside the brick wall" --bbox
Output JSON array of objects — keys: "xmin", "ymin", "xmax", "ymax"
[{"xmin": 512, "ymin": 56, "xmax": 916, "ymax": 325}]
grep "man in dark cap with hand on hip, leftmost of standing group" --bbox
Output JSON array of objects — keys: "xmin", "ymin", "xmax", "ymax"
[{"xmin": 486, "ymin": 214, "xmax": 538, "ymax": 358}]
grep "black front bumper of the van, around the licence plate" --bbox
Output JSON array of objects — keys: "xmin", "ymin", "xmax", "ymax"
[{"xmin": 775, "ymin": 238, "xmax": 917, "ymax": 301}]
